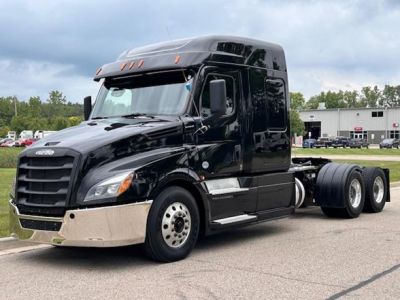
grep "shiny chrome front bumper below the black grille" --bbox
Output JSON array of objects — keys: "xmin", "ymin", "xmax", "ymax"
[{"xmin": 10, "ymin": 201, "xmax": 152, "ymax": 247}]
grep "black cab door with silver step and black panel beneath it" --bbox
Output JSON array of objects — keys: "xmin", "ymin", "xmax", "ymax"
[{"xmin": 193, "ymin": 67, "xmax": 257, "ymax": 220}]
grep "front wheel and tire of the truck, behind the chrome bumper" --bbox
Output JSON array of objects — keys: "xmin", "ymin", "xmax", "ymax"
[{"xmin": 144, "ymin": 186, "xmax": 200, "ymax": 262}]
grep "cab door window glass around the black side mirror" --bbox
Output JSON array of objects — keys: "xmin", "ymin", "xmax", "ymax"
[{"xmin": 200, "ymin": 74, "xmax": 235, "ymax": 118}]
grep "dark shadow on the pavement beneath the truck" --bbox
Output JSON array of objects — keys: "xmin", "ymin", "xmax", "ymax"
[{"xmin": 19, "ymin": 223, "xmax": 288, "ymax": 271}]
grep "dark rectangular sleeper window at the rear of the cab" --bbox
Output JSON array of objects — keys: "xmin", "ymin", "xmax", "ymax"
[{"xmin": 265, "ymin": 79, "xmax": 287, "ymax": 130}]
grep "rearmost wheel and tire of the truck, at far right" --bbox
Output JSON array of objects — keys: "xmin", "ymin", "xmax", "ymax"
[{"xmin": 362, "ymin": 168, "xmax": 388, "ymax": 213}]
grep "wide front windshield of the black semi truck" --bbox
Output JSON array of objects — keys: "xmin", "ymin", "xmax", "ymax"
[{"xmin": 92, "ymin": 70, "xmax": 192, "ymax": 119}]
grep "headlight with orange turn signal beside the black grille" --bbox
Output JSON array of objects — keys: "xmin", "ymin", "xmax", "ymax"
[{"xmin": 83, "ymin": 172, "xmax": 134, "ymax": 202}]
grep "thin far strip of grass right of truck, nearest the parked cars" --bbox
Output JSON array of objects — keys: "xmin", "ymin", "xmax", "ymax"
[{"xmin": 292, "ymin": 148, "xmax": 400, "ymax": 156}]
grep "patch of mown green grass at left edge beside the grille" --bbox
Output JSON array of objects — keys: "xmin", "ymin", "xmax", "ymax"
[{"xmin": 0, "ymin": 169, "xmax": 15, "ymax": 237}]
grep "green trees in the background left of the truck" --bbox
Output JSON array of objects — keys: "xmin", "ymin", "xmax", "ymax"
[{"xmin": 0, "ymin": 91, "xmax": 83, "ymax": 137}]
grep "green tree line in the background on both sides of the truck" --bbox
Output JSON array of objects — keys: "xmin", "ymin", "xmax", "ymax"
[{"xmin": 0, "ymin": 85, "xmax": 400, "ymax": 137}]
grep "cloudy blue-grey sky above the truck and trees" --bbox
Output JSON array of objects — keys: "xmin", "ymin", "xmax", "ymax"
[{"xmin": 0, "ymin": 0, "xmax": 400, "ymax": 102}]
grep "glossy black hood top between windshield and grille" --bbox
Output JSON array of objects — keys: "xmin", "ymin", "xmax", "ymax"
[{"xmin": 27, "ymin": 117, "xmax": 183, "ymax": 167}]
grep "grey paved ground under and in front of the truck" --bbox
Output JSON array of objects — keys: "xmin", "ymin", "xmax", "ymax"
[{"xmin": 0, "ymin": 187, "xmax": 400, "ymax": 299}]
